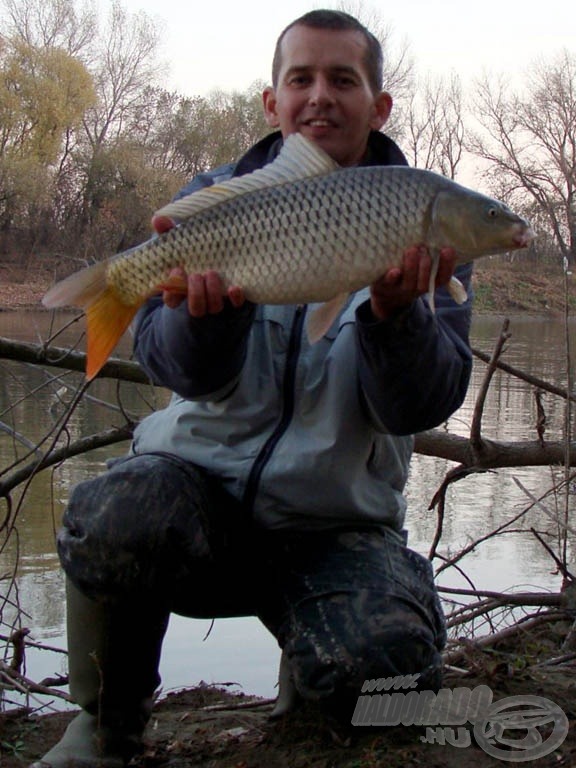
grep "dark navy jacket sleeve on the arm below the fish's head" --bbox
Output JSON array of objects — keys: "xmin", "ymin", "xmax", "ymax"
[{"xmin": 356, "ymin": 264, "xmax": 472, "ymax": 435}]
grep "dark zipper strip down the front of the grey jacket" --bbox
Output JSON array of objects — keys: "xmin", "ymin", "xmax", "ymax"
[{"xmin": 242, "ymin": 305, "xmax": 307, "ymax": 514}]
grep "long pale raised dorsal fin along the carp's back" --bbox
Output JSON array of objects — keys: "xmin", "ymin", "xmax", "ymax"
[{"xmin": 154, "ymin": 133, "xmax": 340, "ymax": 222}]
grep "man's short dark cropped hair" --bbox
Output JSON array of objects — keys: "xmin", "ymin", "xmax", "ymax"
[{"xmin": 272, "ymin": 9, "xmax": 384, "ymax": 93}]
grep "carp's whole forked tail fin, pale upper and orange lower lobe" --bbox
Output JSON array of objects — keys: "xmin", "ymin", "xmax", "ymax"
[{"xmin": 42, "ymin": 261, "xmax": 139, "ymax": 381}]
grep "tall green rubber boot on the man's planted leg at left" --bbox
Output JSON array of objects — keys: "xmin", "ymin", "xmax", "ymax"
[{"xmin": 30, "ymin": 581, "xmax": 169, "ymax": 768}]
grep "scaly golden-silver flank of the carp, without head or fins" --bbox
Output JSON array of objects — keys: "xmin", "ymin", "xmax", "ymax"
[{"xmin": 109, "ymin": 168, "xmax": 431, "ymax": 303}]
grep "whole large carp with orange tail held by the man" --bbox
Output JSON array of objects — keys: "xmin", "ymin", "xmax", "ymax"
[{"xmin": 44, "ymin": 134, "xmax": 533, "ymax": 378}]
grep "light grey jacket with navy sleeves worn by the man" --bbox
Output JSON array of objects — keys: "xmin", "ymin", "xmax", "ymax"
[{"xmin": 132, "ymin": 134, "xmax": 471, "ymax": 530}]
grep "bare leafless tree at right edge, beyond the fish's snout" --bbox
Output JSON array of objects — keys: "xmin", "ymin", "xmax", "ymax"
[{"xmin": 470, "ymin": 50, "xmax": 576, "ymax": 264}]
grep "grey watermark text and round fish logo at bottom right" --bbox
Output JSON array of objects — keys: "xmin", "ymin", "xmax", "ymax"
[{"xmin": 352, "ymin": 675, "xmax": 569, "ymax": 763}]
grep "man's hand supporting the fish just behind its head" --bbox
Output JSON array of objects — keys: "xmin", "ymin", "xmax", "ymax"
[{"xmin": 370, "ymin": 245, "xmax": 456, "ymax": 320}]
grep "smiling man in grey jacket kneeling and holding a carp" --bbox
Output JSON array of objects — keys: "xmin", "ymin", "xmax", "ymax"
[{"xmin": 35, "ymin": 11, "xmax": 471, "ymax": 768}]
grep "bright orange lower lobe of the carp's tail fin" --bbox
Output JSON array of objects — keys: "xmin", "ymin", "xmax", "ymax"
[{"xmin": 86, "ymin": 288, "xmax": 139, "ymax": 381}]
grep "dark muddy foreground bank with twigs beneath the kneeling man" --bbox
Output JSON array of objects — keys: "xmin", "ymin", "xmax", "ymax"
[{"xmin": 5, "ymin": 620, "xmax": 576, "ymax": 768}]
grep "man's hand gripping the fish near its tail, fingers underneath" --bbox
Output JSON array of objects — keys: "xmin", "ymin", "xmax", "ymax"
[{"xmin": 152, "ymin": 216, "xmax": 245, "ymax": 317}]
